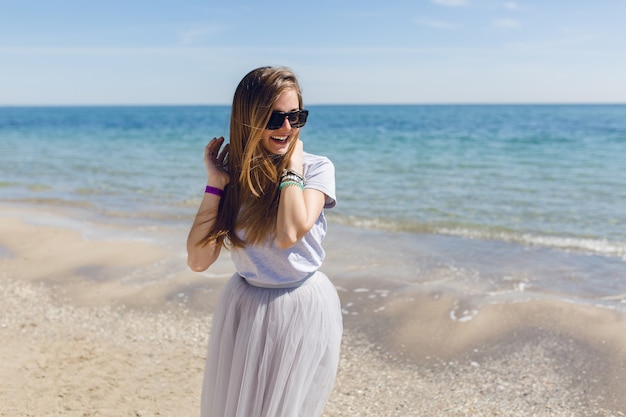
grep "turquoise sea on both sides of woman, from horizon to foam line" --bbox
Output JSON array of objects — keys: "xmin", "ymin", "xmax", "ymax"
[{"xmin": 0, "ymin": 106, "xmax": 626, "ymax": 255}]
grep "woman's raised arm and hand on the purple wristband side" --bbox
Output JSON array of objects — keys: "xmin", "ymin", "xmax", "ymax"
[{"xmin": 187, "ymin": 137, "xmax": 230, "ymax": 272}]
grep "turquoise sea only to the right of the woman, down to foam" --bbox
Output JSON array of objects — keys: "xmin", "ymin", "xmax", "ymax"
[{"xmin": 311, "ymin": 106, "xmax": 626, "ymax": 254}]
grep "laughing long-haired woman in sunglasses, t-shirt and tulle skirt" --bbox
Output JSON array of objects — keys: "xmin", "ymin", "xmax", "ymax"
[{"xmin": 187, "ymin": 67, "xmax": 342, "ymax": 417}]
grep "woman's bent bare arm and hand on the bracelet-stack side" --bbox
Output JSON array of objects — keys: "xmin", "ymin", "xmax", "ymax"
[{"xmin": 276, "ymin": 140, "xmax": 326, "ymax": 249}]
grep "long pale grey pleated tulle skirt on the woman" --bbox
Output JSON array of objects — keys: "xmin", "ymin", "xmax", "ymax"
[{"xmin": 201, "ymin": 272, "xmax": 343, "ymax": 417}]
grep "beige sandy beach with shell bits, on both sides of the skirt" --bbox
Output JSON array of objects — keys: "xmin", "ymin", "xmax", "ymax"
[{"xmin": 0, "ymin": 208, "xmax": 626, "ymax": 417}]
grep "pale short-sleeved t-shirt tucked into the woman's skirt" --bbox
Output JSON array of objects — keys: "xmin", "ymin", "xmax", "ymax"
[{"xmin": 231, "ymin": 152, "xmax": 336, "ymax": 286}]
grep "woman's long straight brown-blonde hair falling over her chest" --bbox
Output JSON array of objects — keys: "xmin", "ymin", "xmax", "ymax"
[{"xmin": 201, "ymin": 67, "xmax": 303, "ymax": 247}]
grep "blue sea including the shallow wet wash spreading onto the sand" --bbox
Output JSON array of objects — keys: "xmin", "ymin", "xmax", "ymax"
[{"xmin": 0, "ymin": 105, "xmax": 626, "ymax": 320}]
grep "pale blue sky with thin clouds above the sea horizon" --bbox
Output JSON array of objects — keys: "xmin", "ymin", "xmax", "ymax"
[{"xmin": 0, "ymin": 0, "xmax": 626, "ymax": 105}]
